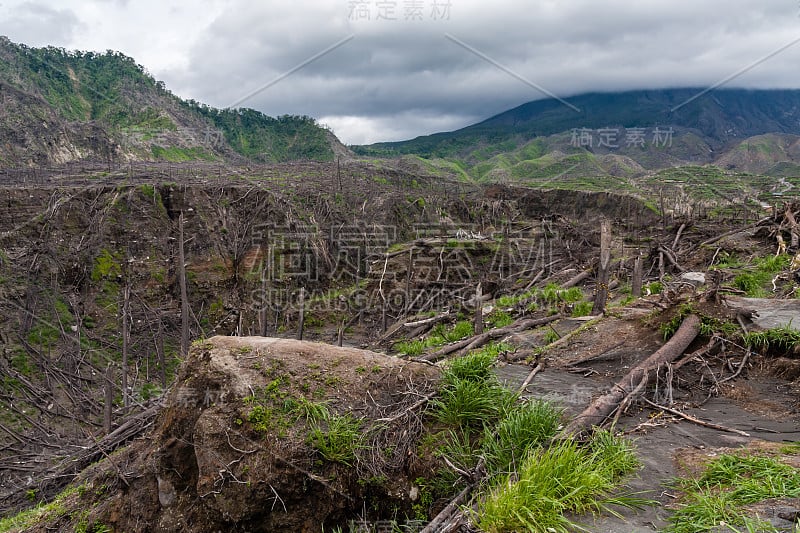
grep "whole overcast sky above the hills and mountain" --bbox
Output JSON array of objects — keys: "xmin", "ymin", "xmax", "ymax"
[{"xmin": 0, "ymin": 0, "xmax": 800, "ymax": 144}]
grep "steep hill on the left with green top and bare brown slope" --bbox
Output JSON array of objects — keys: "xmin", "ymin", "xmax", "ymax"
[{"xmin": 0, "ymin": 37, "xmax": 344, "ymax": 167}]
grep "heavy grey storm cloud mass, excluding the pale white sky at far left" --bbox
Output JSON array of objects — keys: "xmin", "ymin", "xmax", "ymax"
[{"xmin": 161, "ymin": 0, "xmax": 800, "ymax": 142}]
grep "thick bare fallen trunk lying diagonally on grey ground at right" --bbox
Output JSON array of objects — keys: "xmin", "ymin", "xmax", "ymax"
[{"xmin": 561, "ymin": 315, "xmax": 700, "ymax": 437}]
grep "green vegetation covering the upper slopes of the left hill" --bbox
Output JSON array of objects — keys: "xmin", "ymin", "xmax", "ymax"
[{"xmin": 0, "ymin": 40, "xmax": 333, "ymax": 162}]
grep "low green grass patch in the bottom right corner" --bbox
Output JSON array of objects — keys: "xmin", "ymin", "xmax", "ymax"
[{"xmin": 667, "ymin": 454, "xmax": 800, "ymax": 533}]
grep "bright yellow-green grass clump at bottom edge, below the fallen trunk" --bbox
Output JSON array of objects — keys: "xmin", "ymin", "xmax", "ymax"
[{"xmin": 476, "ymin": 431, "xmax": 646, "ymax": 533}]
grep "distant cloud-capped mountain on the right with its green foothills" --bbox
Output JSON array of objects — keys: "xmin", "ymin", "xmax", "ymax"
[{"xmin": 352, "ymin": 88, "xmax": 800, "ymax": 181}]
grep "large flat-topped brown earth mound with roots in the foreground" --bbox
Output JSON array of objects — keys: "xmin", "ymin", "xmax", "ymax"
[{"xmin": 93, "ymin": 337, "xmax": 439, "ymax": 533}]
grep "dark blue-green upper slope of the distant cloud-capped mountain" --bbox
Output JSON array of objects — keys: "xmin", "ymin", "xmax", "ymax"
[{"xmin": 357, "ymin": 88, "xmax": 800, "ymax": 158}]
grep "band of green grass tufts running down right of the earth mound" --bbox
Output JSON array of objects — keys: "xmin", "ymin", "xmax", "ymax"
[{"xmin": 418, "ymin": 345, "xmax": 645, "ymax": 533}]
